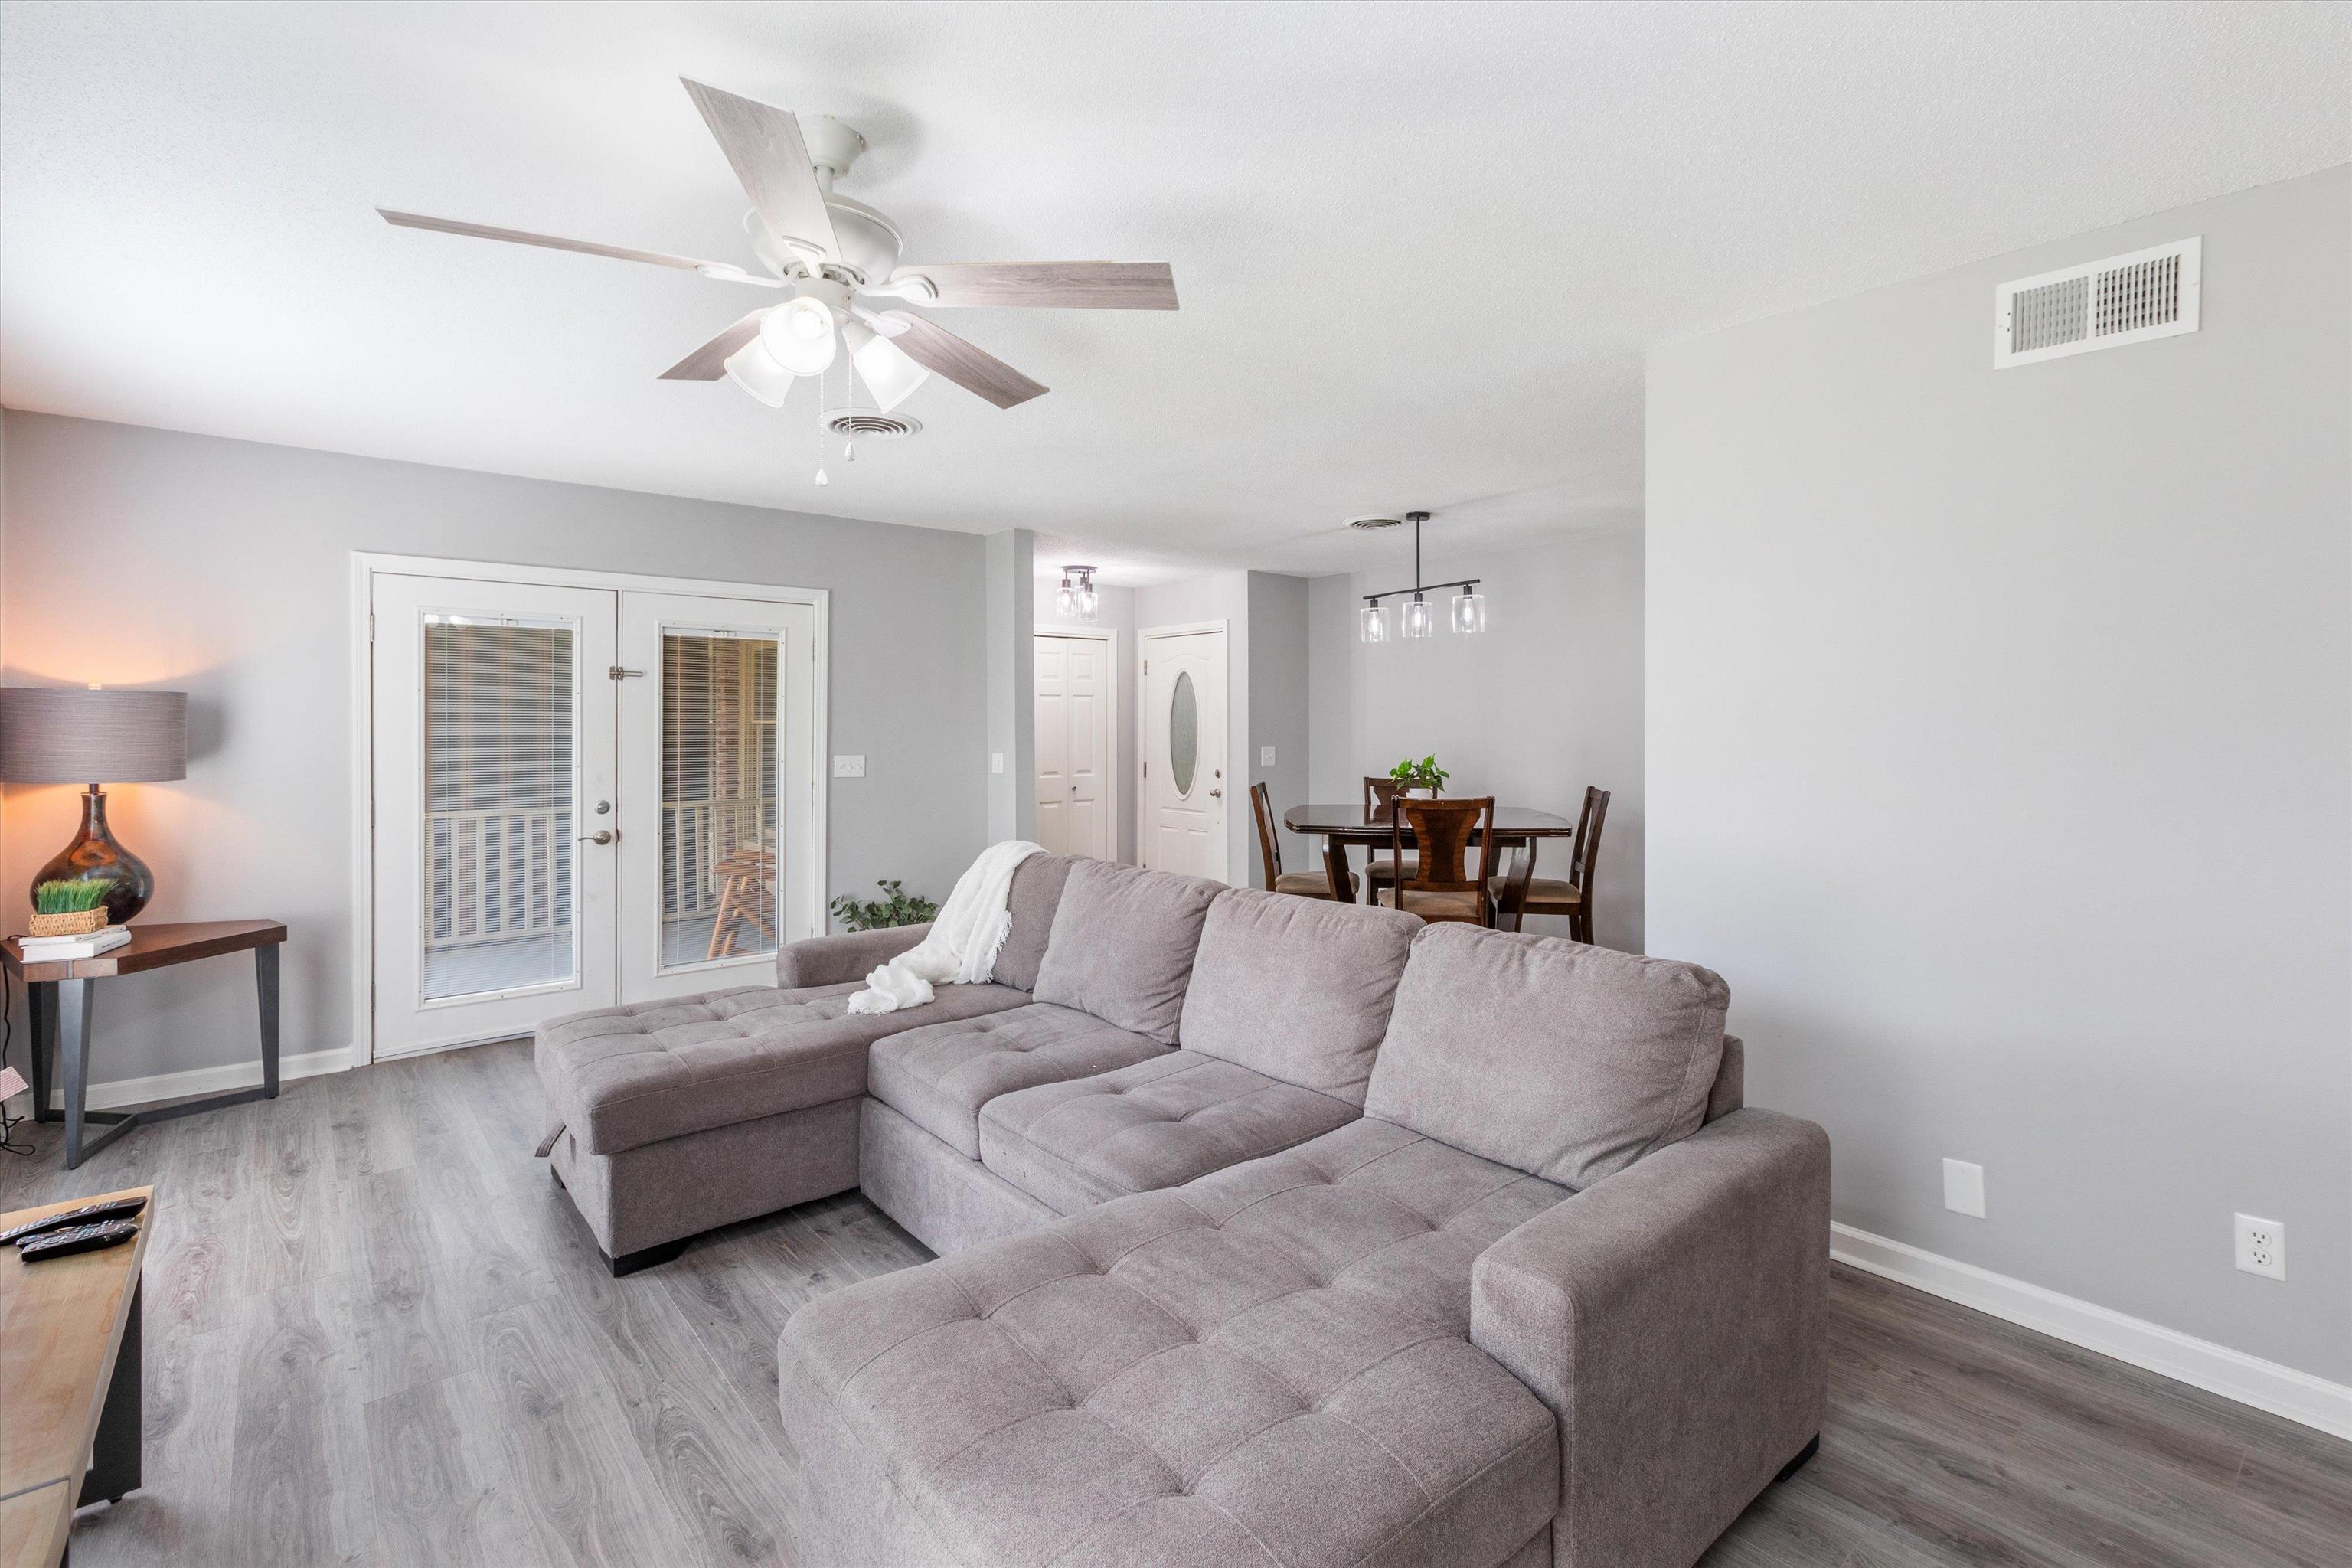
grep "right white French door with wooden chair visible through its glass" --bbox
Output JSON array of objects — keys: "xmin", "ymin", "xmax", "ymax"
[{"xmin": 621, "ymin": 593, "xmax": 823, "ymax": 1001}]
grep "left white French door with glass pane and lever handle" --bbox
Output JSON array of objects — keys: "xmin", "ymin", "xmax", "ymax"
[{"xmin": 371, "ymin": 576, "xmax": 616, "ymax": 1056}]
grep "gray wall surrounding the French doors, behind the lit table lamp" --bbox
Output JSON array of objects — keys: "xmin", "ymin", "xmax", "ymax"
[{"xmin": 0, "ymin": 411, "xmax": 1001, "ymax": 1081}]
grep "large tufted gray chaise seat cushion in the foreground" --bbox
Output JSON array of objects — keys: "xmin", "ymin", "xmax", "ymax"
[{"xmin": 779, "ymin": 1122, "xmax": 1564, "ymax": 1568}]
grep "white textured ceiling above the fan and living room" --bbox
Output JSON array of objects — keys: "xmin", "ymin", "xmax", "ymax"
[{"xmin": 0, "ymin": 0, "xmax": 2352, "ymax": 573}]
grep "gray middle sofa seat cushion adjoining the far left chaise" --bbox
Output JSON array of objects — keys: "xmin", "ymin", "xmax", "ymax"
[{"xmin": 865, "ymin": 988, "xmax": 1167, "ymax": 1159}]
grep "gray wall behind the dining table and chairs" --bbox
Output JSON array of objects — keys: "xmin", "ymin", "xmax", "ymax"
[{"xmin": 1277, "ymin": 529, "xmax": 1644, "ymax": 952}]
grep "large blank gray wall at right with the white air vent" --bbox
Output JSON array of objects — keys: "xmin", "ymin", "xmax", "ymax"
[{"xmin": 1648, "ymin": 169, "xmax": 2352, "ymax": 1382}]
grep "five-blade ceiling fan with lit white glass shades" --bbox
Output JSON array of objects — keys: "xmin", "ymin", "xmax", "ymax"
[{"xmin": 377, "ymin": 77, "xmax": 1176, "ymax": 413}]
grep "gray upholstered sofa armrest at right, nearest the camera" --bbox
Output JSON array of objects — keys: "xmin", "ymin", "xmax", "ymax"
[{"xmin": 1470, "ymin": 1109, "xmax": 1830, "ymax": 1568}]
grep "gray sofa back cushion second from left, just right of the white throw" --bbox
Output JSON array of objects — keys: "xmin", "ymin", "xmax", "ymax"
[{"xmin": 1033, "ymin": 861, "xmax": 1226, "ymax": 1046}]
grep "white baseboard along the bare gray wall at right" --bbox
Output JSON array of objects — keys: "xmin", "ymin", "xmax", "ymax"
[{"xmin": 1830, "ymin": 1223, "xmax": 2352, "ymax": 1439}]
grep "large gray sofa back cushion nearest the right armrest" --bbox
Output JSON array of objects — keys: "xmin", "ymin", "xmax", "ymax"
[{"xmin": 1364, "ymin": 924, "xmax": 1731, "ymax": 1187}]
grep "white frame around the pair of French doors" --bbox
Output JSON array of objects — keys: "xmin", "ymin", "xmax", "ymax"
[{"xmin": 348, "ymin": 550, "xmax": 832, "ymax": 1065}]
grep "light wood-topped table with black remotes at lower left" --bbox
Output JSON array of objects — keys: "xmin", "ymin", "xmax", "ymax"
[{"xmin": 0, "ymin": 1187, "xmax": 155, "ymax": 1568}]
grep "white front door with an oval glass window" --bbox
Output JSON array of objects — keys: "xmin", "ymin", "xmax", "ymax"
[{"xmin": 1138, "ymin": 630, "xmax": 1230, "ymax": 881}]
